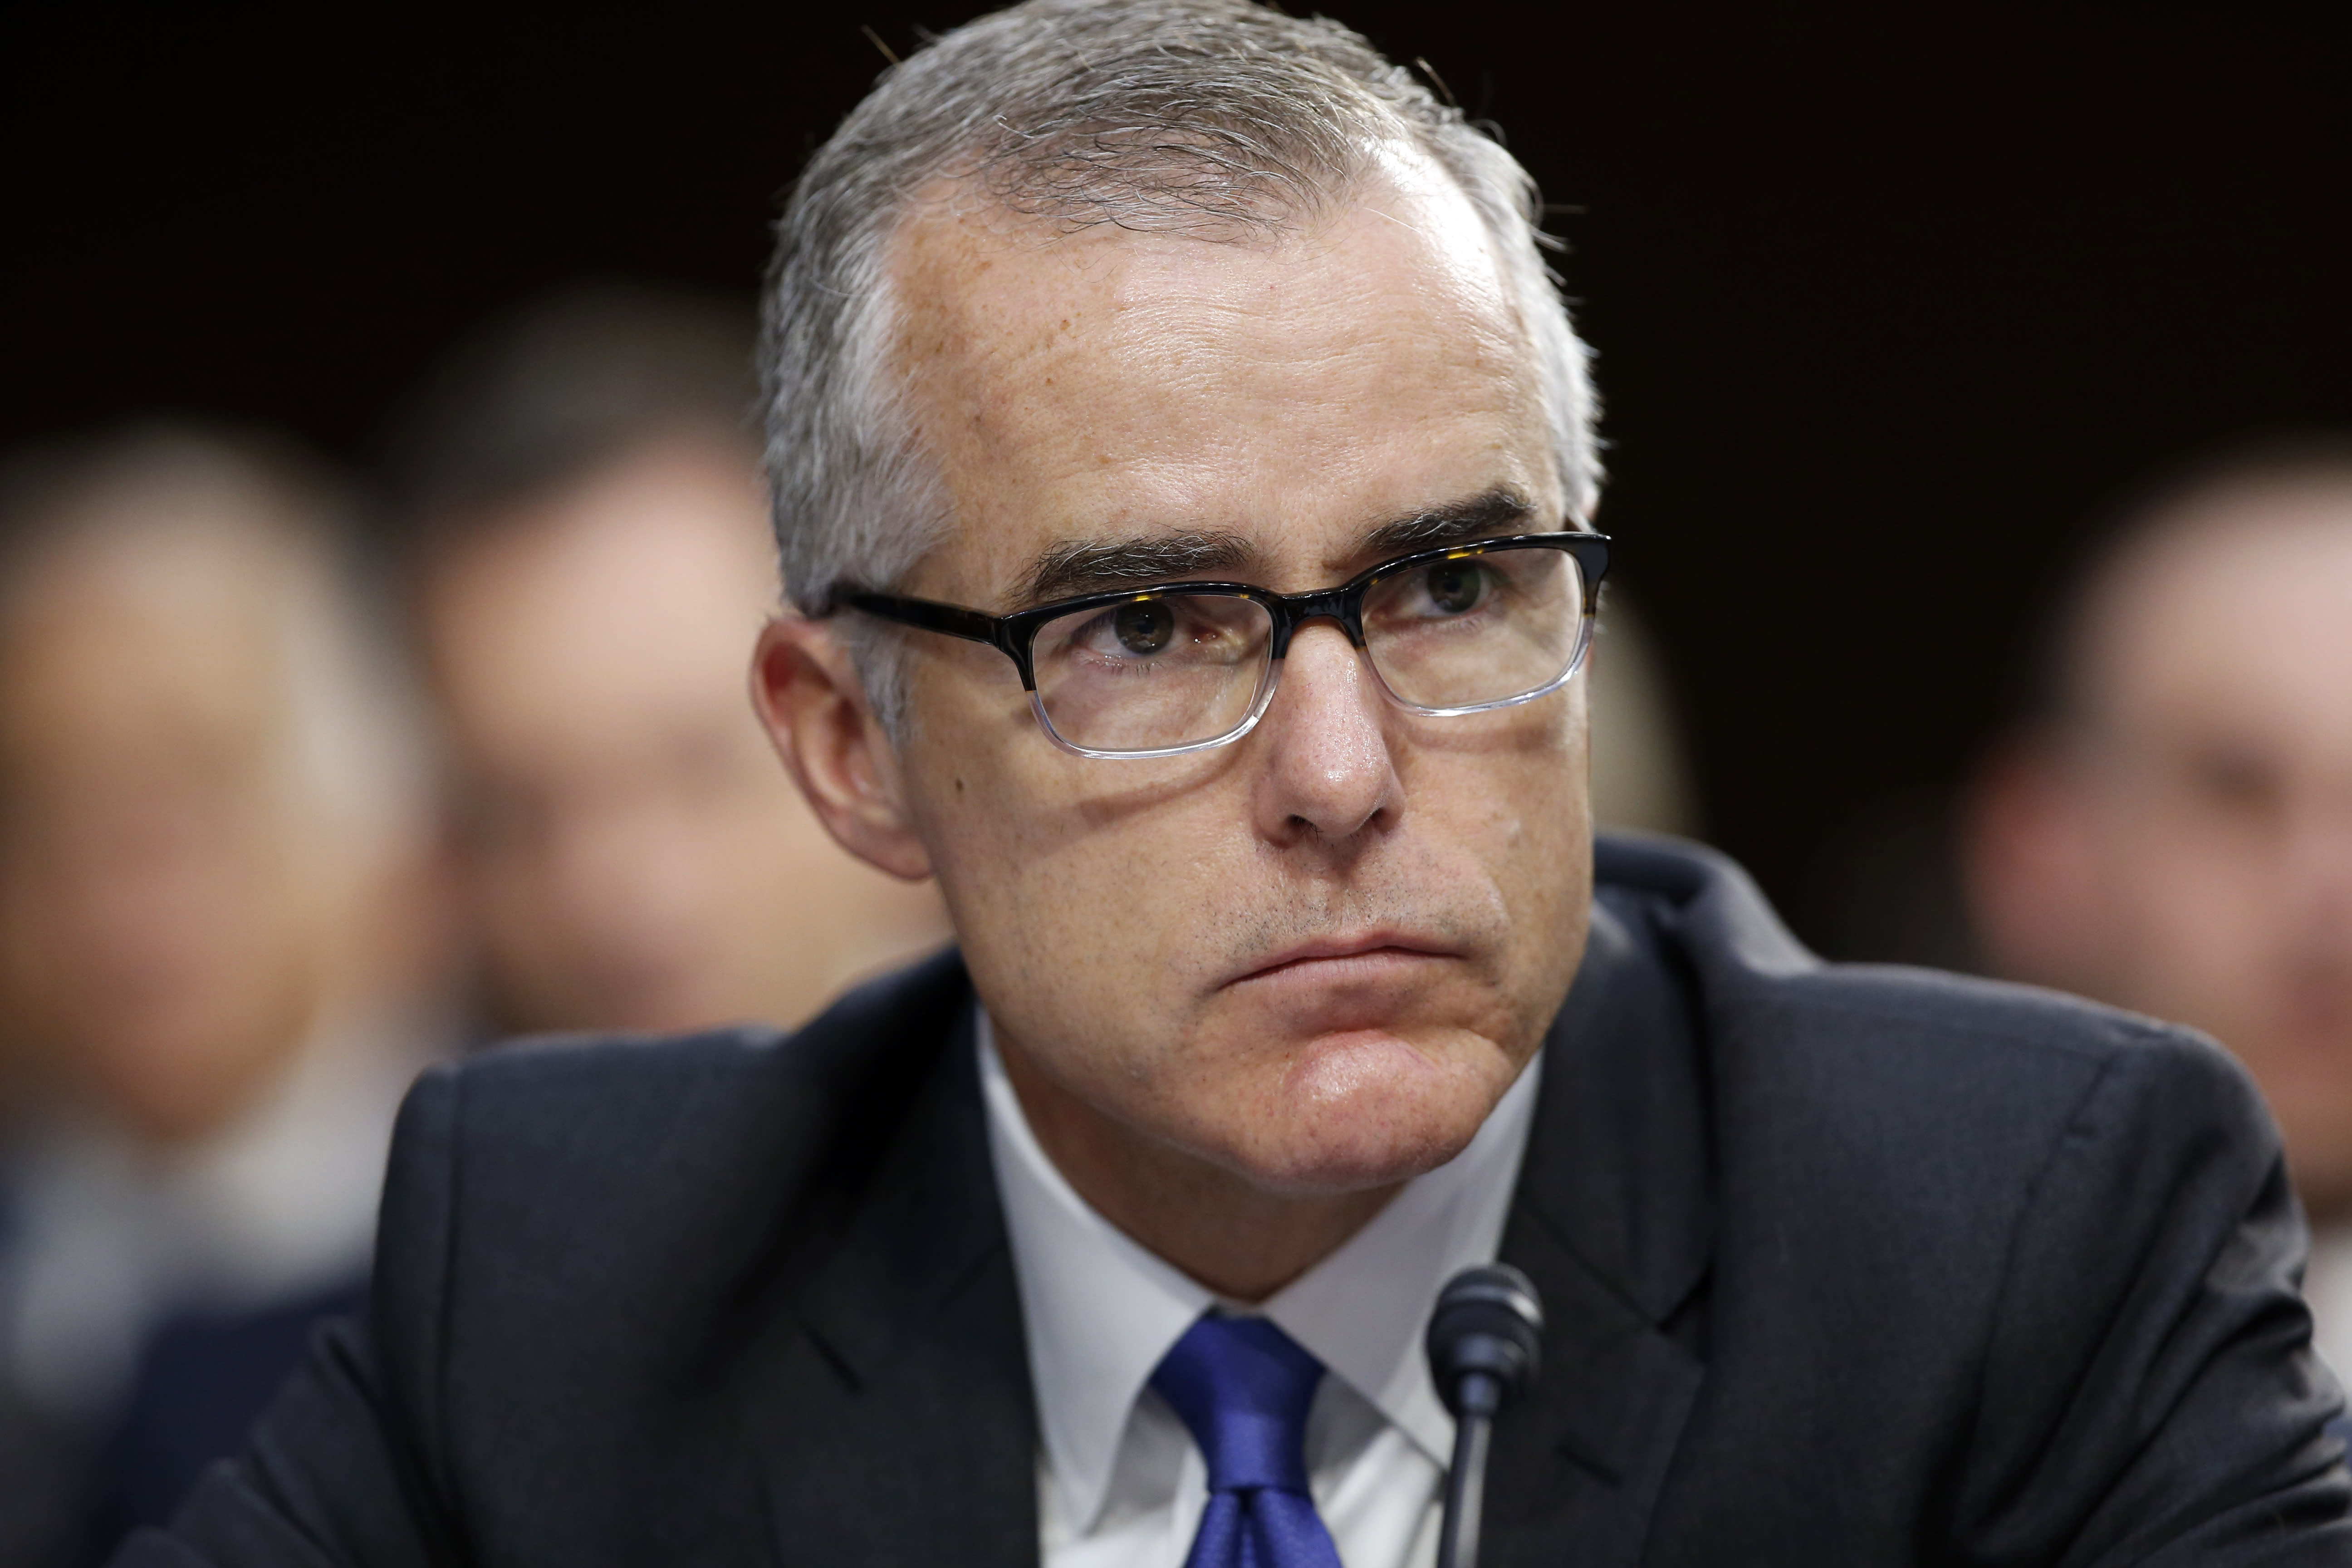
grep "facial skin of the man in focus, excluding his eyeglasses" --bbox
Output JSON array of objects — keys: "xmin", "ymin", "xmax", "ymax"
[{"xmin": 896, "ymin": 169, "xmax": 1590, "ymax": 1194}]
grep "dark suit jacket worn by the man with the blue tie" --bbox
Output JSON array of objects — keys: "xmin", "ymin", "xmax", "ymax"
[{"xmin": 120, "ymin": 842, "xmax": 2352, "ymax": 1568}]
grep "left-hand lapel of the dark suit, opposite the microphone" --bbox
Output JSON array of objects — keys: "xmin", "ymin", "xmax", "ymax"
[{"xmin": 745, "ymin": 987, "xmax": 1037, "ymax": 1568}]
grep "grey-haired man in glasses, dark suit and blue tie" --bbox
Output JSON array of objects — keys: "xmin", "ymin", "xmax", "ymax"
[{"xmin": 129, "ymin": 0, "xmax": 2352, "ymax": 1568}]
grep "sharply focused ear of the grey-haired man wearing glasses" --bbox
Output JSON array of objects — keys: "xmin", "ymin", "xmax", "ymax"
[{"xmin": 750, "ymin": 616, "xmax": 931, "ymax": 882}]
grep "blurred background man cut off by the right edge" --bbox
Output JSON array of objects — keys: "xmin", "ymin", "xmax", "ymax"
[{"xmin": 1966, "ymin": 446, "xmax": 2352, "ymax": 1368}]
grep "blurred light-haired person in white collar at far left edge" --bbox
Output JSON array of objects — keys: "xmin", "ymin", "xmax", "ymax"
[{"xmin": 0, "ymin": 432, "xmax": 437, "ymax": 1566}]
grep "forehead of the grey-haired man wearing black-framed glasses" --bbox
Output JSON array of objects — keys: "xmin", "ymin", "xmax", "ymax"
[{"xmin": 894, "ymin": 156, "xmax": 1557, "ymax": 588}]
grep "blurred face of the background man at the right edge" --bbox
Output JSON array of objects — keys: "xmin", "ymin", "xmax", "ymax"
[{"xmin": 2077, "ymin": 505, "xmax": 2352, "ymax": 1210}]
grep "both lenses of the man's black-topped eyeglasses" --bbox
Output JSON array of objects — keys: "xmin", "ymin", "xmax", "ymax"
[{"xmin": 1030, "ymin": 548, "xmax": 1585, "ymax": 752}]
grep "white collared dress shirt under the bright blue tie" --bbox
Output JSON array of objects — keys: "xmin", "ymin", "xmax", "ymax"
[{"xmin": 979, "ymin": 1013, "xmax": 1541, "ymax": 1568}]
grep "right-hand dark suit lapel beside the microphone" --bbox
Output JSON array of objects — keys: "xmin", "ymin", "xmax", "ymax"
[{"xmin": 1482, "ymin": 903, "xmax": 1712, "ymax": 1568}]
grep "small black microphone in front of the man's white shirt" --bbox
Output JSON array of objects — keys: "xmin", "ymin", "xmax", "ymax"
[{"xmin": 1423, "ymin": 1262, "xmax": 1543, "ymax": 1568}]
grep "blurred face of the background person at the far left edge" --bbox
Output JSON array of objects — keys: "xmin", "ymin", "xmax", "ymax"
[{"xmin": 0, "ymin": 515, "xmax": 334, "ymax": 1142}]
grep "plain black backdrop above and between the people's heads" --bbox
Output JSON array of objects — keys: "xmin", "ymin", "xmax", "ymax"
[{"xmin": 0, "ymin": 0, "xmax": 2352, "ymax": 955}]
